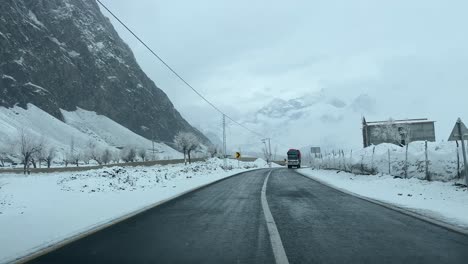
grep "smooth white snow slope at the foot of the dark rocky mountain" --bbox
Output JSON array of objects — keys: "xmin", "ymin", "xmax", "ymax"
[{"xmin": 0, "ymin": 104, "xmax": 183, "ymax": 160}]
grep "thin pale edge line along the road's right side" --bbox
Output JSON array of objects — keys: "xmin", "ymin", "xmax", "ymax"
[{"xmin": 296, "ymin": 171, "xmax": 468, "ymax": 235}]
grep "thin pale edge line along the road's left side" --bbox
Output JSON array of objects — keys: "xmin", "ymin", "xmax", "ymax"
[{"xmin": 11, "ymin": 168, "xmax": 264, "ymax": 263}]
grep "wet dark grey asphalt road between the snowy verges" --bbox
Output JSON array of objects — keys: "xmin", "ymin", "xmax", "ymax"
[{"xmin": 27, "ymin": 169, "xmax": 468, "ymax": 263}]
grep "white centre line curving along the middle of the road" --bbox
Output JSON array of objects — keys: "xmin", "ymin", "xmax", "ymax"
[{"xmin": 261, "ymin": 171, "xmax": 289, "ymax": 264}]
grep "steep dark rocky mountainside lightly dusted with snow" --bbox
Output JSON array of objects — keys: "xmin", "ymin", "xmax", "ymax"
[{"xmin": 0, "ymin": 0, "xmax": 209, "ymax": 143}]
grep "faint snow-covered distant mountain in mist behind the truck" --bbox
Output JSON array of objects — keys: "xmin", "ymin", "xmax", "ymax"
[{"xmin": 227, "ymin": 90, "xmax": 375, "ymax": 156}]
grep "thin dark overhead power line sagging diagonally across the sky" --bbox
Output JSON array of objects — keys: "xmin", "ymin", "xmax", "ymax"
[{"xmin": 96, "ymin": 0, "xmax": 286, "ymax": 146}]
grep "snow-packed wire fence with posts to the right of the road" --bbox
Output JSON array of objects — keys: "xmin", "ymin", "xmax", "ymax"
[{"xmin": 311, "ymin": 141, "xmax": 464, "ymax": 181}]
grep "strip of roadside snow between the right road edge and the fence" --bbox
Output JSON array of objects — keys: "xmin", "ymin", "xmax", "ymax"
[{"xmin": 298, "ymin": 168, "xmax": 468, "ymax": 229}]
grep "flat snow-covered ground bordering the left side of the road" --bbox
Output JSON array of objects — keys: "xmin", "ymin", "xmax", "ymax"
[{"xmin": 0, "ymin": 159, "xmax": 274, "ymax": 263}]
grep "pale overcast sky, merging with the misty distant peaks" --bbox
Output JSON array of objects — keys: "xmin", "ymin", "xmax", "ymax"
[{"xmin": 98, "ymin": 0, "xmax": 468, "ymax": 153}]
